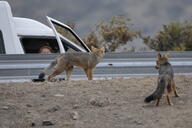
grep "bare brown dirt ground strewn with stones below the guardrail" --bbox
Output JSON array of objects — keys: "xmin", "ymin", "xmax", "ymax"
[{"xmin": 0, "ymin": 75, "xmax": 192, "ymax": 128}]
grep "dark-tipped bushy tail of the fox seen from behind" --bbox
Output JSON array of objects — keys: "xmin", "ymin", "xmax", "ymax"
[{"xmin": 144, "ymin": 77, "xmax": 167, "ymax": 103}]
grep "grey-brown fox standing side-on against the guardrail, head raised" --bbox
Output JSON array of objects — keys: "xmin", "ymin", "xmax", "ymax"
[{"xmin": 39, "ymin": 47, "xmax": 105, "ymax": 80}]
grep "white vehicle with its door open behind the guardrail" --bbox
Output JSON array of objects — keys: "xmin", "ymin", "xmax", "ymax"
[{"xmin": 0, "ymin": 1, "xmax": 90, "ymax": 54}]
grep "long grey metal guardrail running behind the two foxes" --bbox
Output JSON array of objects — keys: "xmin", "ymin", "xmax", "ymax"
[{"xmin": 0, "ymin": 52, "xmax": 192, "ymax": 80}]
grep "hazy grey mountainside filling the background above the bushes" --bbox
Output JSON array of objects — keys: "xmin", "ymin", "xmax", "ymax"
[{"xmin": 7, "ymin": 0, "xmax": 192, "ymax": 51}]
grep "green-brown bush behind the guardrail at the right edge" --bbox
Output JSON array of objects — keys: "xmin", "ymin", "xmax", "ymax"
[{"xmin": 143, "ymin": 22, "xmax": 192, "ymax": 51}]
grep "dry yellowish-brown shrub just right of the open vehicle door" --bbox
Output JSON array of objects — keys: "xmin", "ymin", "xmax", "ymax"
[{"xmin": 83, "ymin": 16, "xmax": 139, "ymax": 51}]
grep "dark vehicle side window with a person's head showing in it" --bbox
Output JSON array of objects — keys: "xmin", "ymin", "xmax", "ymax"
[{"xmin": 21, "ymin": 37, "xmax": 60, "ymax": 53}]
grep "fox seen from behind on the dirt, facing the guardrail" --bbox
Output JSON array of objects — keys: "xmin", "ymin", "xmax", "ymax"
[{"xmin": 145, "ymin": 53, "xmax": 179, "ymax": 106}]
